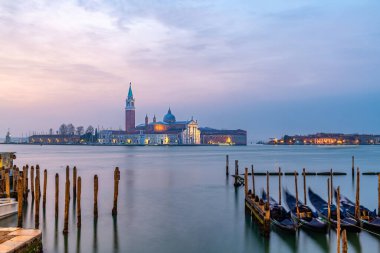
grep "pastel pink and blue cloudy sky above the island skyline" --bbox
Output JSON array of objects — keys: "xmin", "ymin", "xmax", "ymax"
[{"xmin": 0, "ymin": 0, "xmax": 380, "ymax": 141}]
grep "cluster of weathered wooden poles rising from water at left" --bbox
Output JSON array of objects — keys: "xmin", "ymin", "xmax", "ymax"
[{"xmin": 10, "ymin": 165, "xmax": 120, "ymax": 234}]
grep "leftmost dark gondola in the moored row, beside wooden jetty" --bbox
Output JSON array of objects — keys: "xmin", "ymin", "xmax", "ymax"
[{"xmin": 262, "ymin": 190, "xmax": 298, "ymax": 233}]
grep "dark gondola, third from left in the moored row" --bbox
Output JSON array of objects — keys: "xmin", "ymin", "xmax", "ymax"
[{"xmin": 308, "ymin": 187, "xmax": 361, "ymax": 233}]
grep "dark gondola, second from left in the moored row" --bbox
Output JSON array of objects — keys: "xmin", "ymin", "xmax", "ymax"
[{"xmin": 284, "ymin": 190, "xmax": 328, "ymax": 233}]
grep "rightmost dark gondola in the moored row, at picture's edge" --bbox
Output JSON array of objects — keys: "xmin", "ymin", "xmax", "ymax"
[{"xmin": 335, "ymin": 190, "xmax": 380, "ymax": 232}]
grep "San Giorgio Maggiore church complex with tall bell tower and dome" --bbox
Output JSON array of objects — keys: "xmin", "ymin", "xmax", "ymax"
[{"xmin": 99, "ymin": 83, "xmax": 247, "ymax": 145}]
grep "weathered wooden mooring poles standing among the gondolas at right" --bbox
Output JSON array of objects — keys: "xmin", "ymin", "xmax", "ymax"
[{"xmin": 226, "ymin": 155, "xmax": 380, "ymax": 253}]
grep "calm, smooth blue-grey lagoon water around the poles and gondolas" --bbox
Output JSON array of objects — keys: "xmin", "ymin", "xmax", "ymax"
[{"xmin": 0, "ymin": 145, "xmax": 380, "ymax": 253}]
